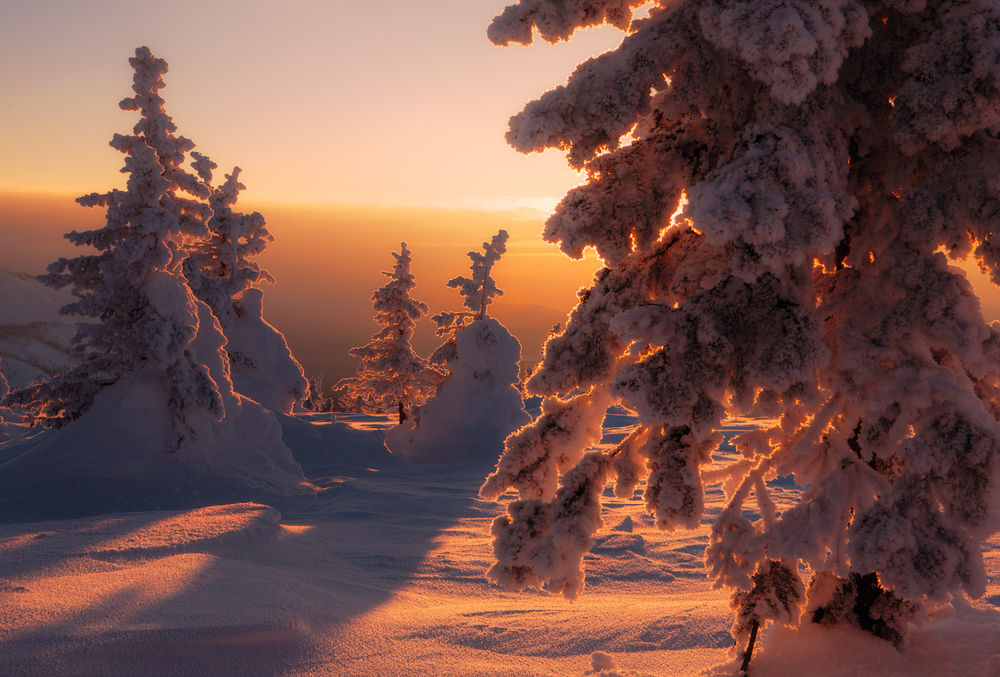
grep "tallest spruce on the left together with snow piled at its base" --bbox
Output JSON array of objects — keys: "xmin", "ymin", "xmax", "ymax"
[{"xmin": 0, "ymin": 47, "xmax": 302, "ymax": 492}]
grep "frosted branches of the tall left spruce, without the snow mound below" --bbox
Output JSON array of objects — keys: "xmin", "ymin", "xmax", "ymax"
[{"xmin": 12, "ymin": 47, "xmax": 230, "ymax": 438}]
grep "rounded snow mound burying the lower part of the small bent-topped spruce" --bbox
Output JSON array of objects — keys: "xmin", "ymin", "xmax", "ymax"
[{"xmin": 386, "ymin": 317, "xmax": 531, "ymax": 463}]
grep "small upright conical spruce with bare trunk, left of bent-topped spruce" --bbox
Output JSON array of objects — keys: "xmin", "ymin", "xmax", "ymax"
[{"xmin": 334, "ymin": 242, "xmax": 443, "ymax": 423}]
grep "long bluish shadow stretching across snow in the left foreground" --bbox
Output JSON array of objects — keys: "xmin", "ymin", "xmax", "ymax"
[{"xmin": 0, "ymin": 417, "xmax": 497, "ymax": 677}]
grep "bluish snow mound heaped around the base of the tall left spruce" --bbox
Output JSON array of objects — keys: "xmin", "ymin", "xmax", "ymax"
[{"xmin": 0, "ymin": 368, "xmax": 309, "ymax": 519}]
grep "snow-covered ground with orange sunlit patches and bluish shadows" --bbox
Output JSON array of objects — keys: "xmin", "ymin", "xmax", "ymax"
[{"xmin": 0, "ymin": 405, "xmax": 1000, "ymax": 677}]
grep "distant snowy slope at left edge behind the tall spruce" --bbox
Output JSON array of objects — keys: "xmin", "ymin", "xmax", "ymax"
[{"xmin": 0, "ymin": 269, "xmax": 77, "ymax": 388}]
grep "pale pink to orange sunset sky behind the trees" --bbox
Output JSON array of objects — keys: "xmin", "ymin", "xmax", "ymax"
[{"xmin": 0, "ymin": 0, "xmax": 1000, "ymax": 377}]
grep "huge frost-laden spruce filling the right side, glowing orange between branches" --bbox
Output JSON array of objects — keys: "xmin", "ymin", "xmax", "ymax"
[{"xmin": 482, "ymin": 0, "xmax": 1000, "ymax": 664}]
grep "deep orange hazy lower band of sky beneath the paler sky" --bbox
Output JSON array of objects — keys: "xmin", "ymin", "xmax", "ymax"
[{"xmin": 0, "ymin": 192, "xmax": 599, "ymax": 380}]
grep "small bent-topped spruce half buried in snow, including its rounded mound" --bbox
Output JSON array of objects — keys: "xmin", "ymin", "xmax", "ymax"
[{"xmin": 385, "ymin": 230, "xmax": 531, "ymax": 463}]
